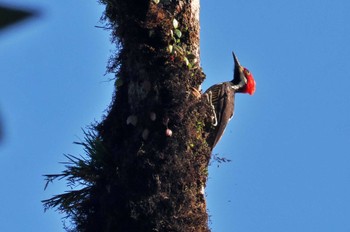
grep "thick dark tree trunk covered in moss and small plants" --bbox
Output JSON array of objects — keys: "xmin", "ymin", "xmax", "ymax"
[{"xmin": 44, "ymin": 0, "xmax": 210, "ymax": 232}]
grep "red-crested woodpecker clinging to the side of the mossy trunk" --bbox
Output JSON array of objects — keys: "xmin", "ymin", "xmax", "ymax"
[{"xmin": 203, "ymin": 52, "xmax": 256, "ymax": 150}]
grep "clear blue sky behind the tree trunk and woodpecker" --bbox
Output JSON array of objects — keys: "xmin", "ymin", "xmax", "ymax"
[{"xmin": 0, "ymin": 0, "xmax": 350, "ymax": 232}]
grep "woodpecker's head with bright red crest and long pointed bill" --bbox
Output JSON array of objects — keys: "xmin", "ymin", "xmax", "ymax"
[{"xmin": 232, "ymin": 52, "xmax": 256, "ymax": 95}]
